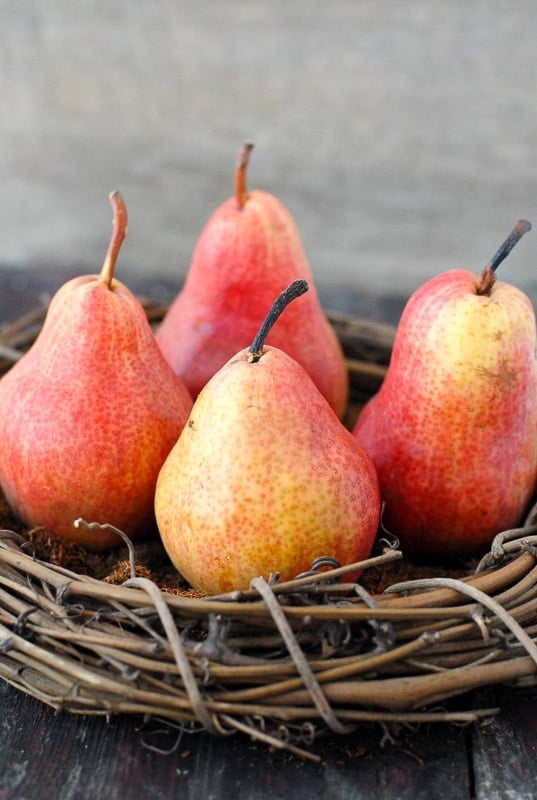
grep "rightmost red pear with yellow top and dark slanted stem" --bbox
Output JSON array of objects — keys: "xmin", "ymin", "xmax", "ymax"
[{"xmin": 353, "ymin": 220, "xmax": 537, "ymax": 560}]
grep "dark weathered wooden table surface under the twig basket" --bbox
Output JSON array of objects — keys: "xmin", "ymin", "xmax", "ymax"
[{"xmin": 0, "ymin": 270, "xmax": 537, "ymax": 800}]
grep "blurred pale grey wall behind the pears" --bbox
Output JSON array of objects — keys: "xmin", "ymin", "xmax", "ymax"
[{"xmin": 0, "ymin": 0, "xmax": 537, "ymax": 316}]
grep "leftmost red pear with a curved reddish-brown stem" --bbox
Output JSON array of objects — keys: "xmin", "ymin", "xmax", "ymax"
[{"xmin": 0, "ymin": 192, "xmax": 192, "ymax": 550}]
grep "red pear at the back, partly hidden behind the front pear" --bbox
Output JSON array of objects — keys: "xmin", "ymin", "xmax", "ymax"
[{"xmin": 156, "ymin": 144, "xmax": 348, "ymax": 416}]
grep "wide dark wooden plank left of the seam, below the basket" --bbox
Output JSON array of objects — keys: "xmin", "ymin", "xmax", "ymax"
[{"xmin": 0, "ymin": 683, "xmax": 470, "ymax": 800}]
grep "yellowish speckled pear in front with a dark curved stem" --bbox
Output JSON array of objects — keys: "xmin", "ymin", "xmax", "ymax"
[{"xmin": 155, "ymin": 280, "xmax": 380, "ymax": 594}]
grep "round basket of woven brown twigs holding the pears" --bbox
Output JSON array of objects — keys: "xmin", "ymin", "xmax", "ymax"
[{"xmin": 0, "ymin": 301, "xmax": 537, "ymax": 758}]
